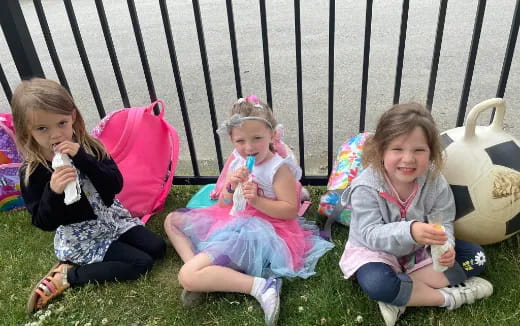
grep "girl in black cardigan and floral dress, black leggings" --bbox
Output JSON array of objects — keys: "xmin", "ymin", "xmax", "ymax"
[{"xmin": 12, "ymin": 78, "xmax": 166, "ymax": 312}]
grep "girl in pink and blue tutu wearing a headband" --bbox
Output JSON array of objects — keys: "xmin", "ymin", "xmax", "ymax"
[{"xmin": 164, "ymin": 95, "xmax": 333, "ymax": 325}]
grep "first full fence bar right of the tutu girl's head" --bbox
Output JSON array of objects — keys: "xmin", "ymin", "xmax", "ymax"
[{"xmin": 294, "ymin": 0, "xmax": 305, "ymax": 177}]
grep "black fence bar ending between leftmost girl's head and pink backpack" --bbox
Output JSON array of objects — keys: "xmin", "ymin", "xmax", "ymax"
[{"xmin": 63, "ymin": 0, "xmax": 106, "ymax": 118}]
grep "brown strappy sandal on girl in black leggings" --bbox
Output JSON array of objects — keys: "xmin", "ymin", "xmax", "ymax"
[{"xmin": 27, "ymin": 263, "xmax": 71, "ymax": 313}]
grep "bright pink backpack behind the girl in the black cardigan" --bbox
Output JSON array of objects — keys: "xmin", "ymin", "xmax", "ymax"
[{"xmin": 92, "ymin": 100, "xmax": 179, "ymax": 223}]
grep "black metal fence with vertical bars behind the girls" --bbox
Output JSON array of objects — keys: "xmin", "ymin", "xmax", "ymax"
[{"xmin": 0, "ymin": 0, "xmax": 520, "ymax": 185}]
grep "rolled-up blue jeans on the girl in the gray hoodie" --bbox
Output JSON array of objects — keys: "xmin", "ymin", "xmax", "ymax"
[{"xmin": 356, "ymin": 240, "xmax": 486, "ymax": 306}]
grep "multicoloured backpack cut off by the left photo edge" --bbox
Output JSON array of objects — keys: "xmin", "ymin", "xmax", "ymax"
[{"xmin": 0, "ymin": 113, "xmax": 24, "ymax": 211}]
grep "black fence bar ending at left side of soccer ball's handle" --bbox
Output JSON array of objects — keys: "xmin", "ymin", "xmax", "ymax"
[{"xmin": 456, "ymin": 0, "xmax": 486, "ymax": 127}]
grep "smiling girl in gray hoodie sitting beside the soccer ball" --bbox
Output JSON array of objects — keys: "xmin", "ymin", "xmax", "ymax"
[{"xmin": 340, "ymin": 103, "xmax": 493, "ymax": 325}]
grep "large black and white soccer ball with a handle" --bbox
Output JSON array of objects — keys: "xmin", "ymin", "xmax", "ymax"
[{"xmin": 441, "ymin": 99, "xmax": 520, "ymax": 244}]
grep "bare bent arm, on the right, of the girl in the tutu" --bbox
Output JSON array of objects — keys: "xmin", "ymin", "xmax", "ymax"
[{"xmin": 243, "ymin": 165, "xmax": 298, "ymax": 219}]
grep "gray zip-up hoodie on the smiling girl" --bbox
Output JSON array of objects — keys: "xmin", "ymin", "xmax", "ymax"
[{"xmin": 341, "ymin": 167, "xmax": 455, "ymax": 257}]
